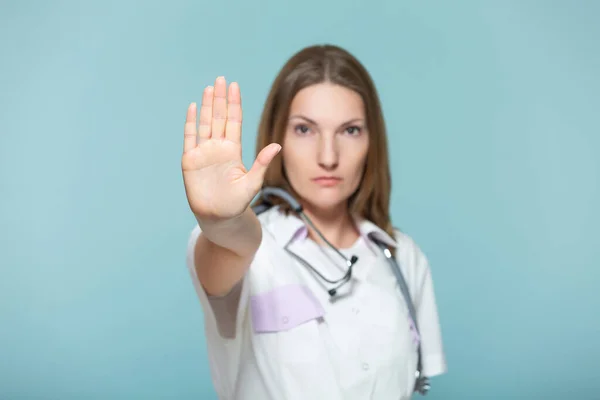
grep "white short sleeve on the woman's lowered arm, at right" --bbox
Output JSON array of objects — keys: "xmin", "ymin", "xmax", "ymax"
[{"xmin": 414, "ymin": 244, "xmax": 447, "ymax": 377}]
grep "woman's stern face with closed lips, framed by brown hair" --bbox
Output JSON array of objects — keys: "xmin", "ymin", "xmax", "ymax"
[{"xmin": 282, "ymin": 83, "xmax": 369, "ymax": 211}]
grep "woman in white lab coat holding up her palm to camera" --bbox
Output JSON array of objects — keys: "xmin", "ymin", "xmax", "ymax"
[{"xmin": 182, "ymin": 46, "xmax": 446, "ymax": 400}]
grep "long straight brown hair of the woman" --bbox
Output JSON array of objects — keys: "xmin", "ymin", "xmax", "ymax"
[{"xmin": 255, "ymin": 45, "xmax": 394, "ymax": 237}]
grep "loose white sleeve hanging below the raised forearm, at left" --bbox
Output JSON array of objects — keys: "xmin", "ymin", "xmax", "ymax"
[{"xmin": 186, "ymin": 225, "xmax": 248, "ymax": 398}]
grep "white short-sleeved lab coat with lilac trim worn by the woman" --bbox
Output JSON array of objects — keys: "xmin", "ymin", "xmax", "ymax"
[{"xmin": 187, "ymin": 207, "xmax": 446, "ymax": 400}]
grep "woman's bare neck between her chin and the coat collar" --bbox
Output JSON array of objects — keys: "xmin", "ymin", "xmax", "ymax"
[{"xmin": 303, "ymin": 204, "xmax": 359, "ymax": 248}]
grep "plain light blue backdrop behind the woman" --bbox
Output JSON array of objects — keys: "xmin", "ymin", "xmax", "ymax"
[{"xmin": 0, "ymin": 0, "xmax": 600, "ymax": 400}]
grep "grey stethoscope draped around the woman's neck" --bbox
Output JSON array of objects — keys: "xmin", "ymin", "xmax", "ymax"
[{"xmin": 252, "ymin": 187, "xmax": 431, "ymax": 395}]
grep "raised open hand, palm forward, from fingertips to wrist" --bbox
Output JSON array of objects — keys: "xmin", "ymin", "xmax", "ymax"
[{"xmin": 181, "ymin": 77, "xmax": 281, "ymax": 222}]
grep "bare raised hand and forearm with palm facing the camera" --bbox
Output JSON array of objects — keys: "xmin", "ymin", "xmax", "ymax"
[{"xmin": 181, "ymin": 77, "xmax": 281, "ymax": 296}]
